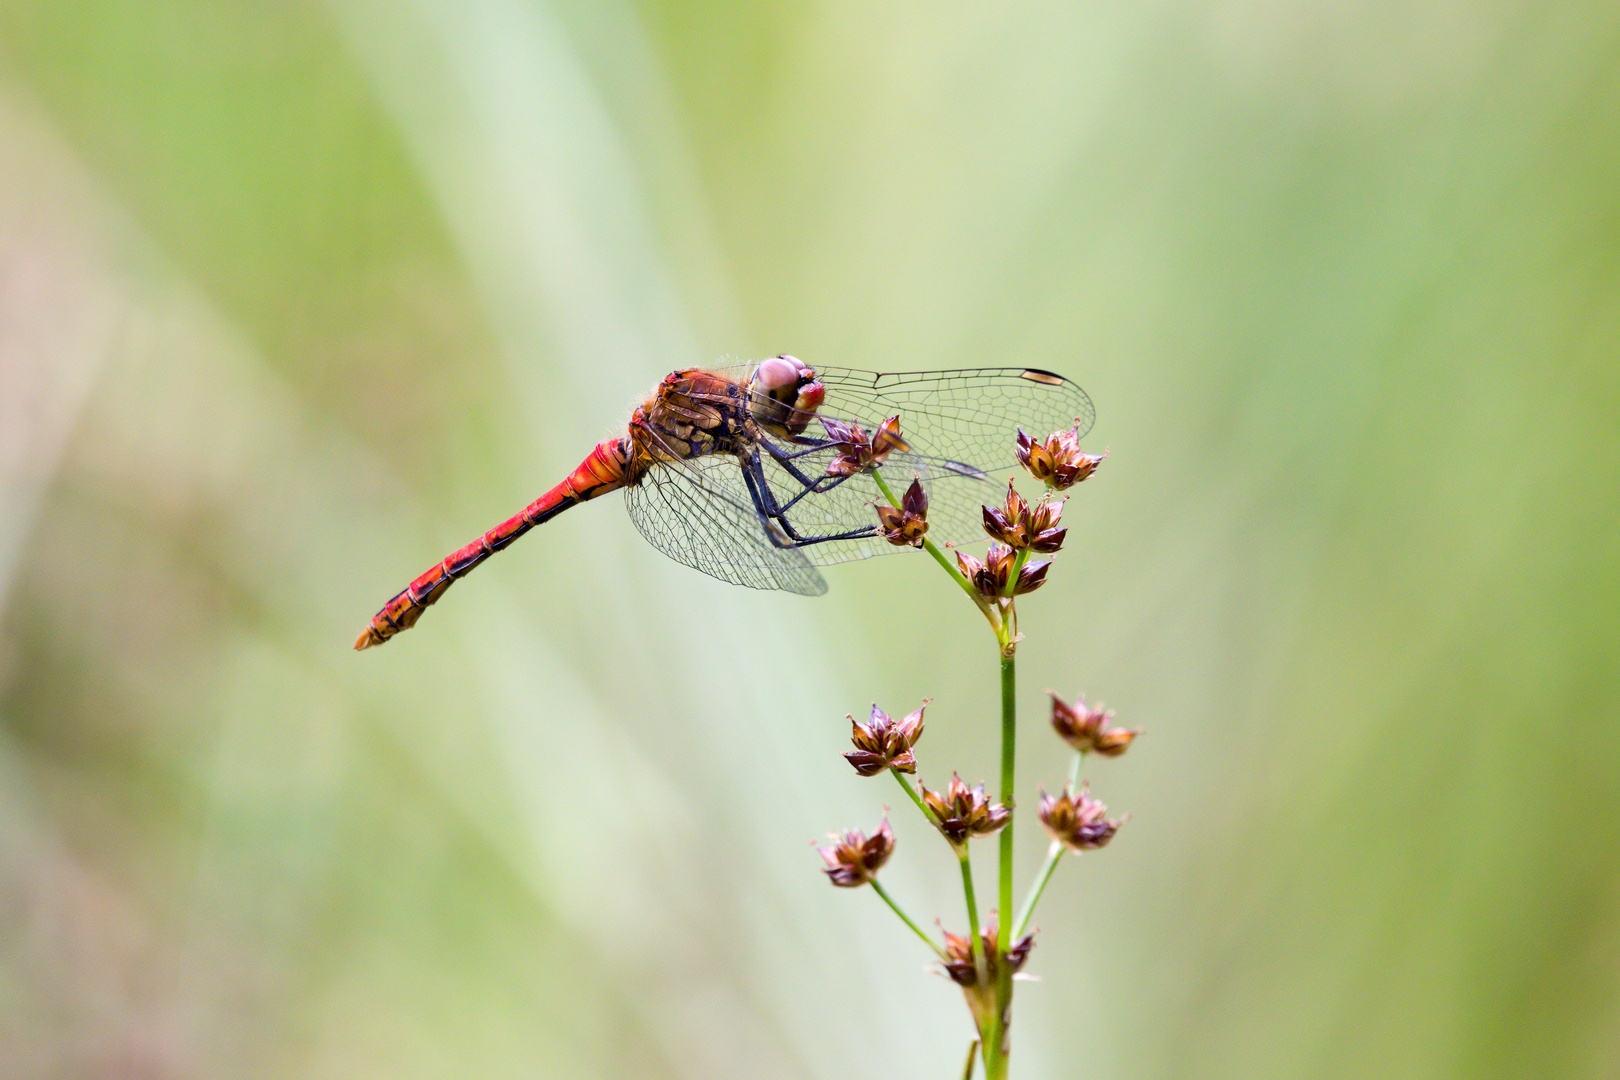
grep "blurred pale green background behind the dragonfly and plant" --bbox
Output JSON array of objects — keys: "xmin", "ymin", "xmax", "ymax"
[{"xmin": 0, "ymin": 0, "xmax": 1620, "ymax": 1080}]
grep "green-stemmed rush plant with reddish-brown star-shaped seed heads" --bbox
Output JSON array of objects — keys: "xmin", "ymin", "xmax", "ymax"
[{"xmin": 820, "ymin": 429, "xmax": 1140, "ymax": 1080}]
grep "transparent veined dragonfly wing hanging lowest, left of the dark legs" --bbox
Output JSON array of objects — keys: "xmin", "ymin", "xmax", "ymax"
[{"xmin": 624, "ymin": 455, "xmax": 826, "ymax": 596}]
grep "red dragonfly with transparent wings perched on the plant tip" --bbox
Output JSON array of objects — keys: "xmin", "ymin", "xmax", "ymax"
[{"xmin": 355, "ymin": 355, "xmax": 1095, "ymax": 649}]
